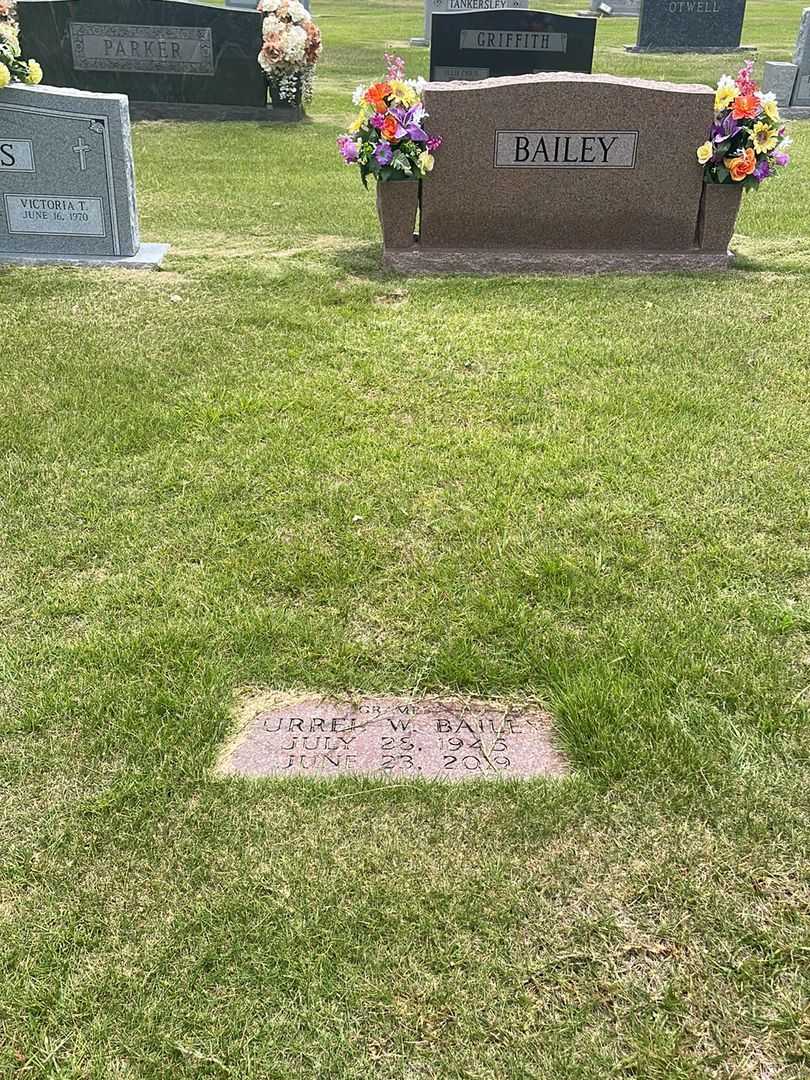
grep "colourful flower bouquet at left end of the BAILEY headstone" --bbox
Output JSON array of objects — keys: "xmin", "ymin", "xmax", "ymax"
[{"xmin": 338, "ymin": 53, "xmax": 442, "ymax": 187}]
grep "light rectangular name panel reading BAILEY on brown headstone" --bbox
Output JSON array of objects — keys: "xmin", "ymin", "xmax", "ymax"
[{"xmin": 495, "ymin": 131, "xmax": 638, "ymax": 168}]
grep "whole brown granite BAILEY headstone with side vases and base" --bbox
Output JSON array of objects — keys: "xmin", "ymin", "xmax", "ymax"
[{"xmin": 377, "ymin": 72, "xmax": 741, "ymax": 273}]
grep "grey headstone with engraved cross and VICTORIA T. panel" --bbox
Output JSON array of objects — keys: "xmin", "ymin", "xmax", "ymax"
[{"xmin": 0, "ymin": 84, "xmax": 167, "ymax": 267}]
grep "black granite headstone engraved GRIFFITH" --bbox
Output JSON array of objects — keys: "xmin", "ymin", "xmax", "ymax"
[{"xmin": 430, "ymin": 11, "xmax": 596, "ymax": 82}]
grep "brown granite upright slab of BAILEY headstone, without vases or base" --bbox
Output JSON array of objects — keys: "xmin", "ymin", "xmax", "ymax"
[{"xmin": 419, "ymin": 73, "xmax": 714, "ymax": 253}]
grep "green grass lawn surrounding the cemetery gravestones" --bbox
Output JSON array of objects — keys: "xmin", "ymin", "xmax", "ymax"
[{"xmin": 0, "ymin": 0, "xmax": 810, "ymax": 1080}]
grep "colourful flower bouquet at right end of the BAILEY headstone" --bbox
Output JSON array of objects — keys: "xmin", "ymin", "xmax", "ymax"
[{"xmin": 698, "ymin": 60, "xmax": 791, "ymax": 188}]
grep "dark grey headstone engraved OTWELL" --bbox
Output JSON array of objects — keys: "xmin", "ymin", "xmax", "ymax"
[{"xmin": 629, "ymin": 0, "xmax": 751, "ymax": 53}]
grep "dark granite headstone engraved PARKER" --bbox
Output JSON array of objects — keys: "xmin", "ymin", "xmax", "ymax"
[{"xmin": 17, "ymin": 0, "xmax": 271, "ymax": 120}]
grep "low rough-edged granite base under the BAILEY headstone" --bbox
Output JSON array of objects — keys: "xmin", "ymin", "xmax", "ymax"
[{"xmin": 382, "ymin": 246, "xmax": 733, "ymax": 276}]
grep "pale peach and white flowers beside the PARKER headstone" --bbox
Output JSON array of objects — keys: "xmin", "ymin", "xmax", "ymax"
[{"xmin": 257, "ymin": 0, "xmax": 321, "ymax": 105}]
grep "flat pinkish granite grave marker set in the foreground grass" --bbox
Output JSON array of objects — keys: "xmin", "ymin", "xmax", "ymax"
[{"xmin": 218, "ymin": 698, "xmax": 567, "ymax": 780}]
